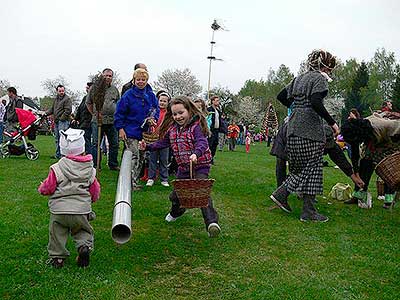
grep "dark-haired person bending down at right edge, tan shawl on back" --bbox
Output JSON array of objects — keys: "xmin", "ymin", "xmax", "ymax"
[{"xmin": 341, "ymin": 113, "xmax": 400, "ymax": 208}]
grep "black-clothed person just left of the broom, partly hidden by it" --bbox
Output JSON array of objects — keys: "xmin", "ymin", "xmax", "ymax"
[{"xmin": 72, "ymin": 82, "xmax": 93, "ymax": 154}]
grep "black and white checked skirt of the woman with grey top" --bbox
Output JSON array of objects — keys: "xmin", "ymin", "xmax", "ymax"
[{"xmin": 285, "ymin": 136, "xmax": 325, "ymax": 195}]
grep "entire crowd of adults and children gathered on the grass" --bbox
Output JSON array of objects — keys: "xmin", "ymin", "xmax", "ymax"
[{"xmin": 0, "ymin": 50, "xmax": 400, "ymax": 268}]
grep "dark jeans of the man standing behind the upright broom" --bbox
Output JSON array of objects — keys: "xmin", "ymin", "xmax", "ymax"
[{"xmin": 91, "ymin": 122, "xmax": 119, "ymax": 168}]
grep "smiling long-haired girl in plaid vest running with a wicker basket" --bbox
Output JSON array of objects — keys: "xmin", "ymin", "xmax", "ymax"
[{"xmin": 140, "ymin": 96, "xmax": 221, "ymax": 237}]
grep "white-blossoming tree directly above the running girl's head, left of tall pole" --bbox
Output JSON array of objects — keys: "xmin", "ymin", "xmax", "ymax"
[{"xmin": 153, "ymin": 68, "xmax": 202, "ymax": 97}]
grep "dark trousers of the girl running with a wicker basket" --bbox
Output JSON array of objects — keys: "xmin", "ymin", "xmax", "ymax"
[{"xmin": 169, "ymin": 173, "xmax": 218, "ymax": 230}]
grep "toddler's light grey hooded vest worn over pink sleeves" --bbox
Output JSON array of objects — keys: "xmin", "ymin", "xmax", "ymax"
[{"xmin": 49, "ymin": 157, "xmax": 96, "ymax": 215}]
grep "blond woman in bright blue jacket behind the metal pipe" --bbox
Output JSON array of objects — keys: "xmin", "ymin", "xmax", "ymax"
[{"xmin": 114, "ymin": 68, "xmax": 160, "ymax": 191}]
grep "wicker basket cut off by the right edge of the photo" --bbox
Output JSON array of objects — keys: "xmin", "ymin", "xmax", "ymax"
[{"xmin": 375, "ymin": 152, "xmax": 400, "ymax": 191}]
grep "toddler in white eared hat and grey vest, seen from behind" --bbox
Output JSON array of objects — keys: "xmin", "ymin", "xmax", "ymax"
[{"xmin": 38, "ymin": 128, "xmax": 100, "ymax": 269}]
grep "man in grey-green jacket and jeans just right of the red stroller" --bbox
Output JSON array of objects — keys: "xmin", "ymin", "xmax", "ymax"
[{"xmin": 46, "ymin": 84, "xmax": 72, "ymax": 159}]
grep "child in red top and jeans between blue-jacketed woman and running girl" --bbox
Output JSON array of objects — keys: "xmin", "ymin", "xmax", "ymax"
[{"xmin": 146, "ymin": 91, "xmax": 171, "ymax": 187}]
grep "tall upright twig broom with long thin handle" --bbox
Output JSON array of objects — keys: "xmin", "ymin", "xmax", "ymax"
[{"xmin": 91, "ymin": 74, "xmax": 108, "ymax": 174}]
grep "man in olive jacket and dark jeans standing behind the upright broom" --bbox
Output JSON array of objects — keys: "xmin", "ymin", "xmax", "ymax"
[{"xmin": 86, "ymin": 68, "xmax": 119, "ymax": 171}]
